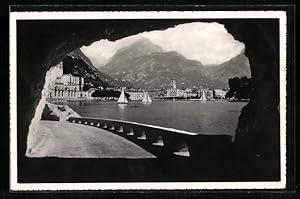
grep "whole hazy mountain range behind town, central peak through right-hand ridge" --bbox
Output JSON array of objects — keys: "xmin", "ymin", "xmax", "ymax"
[{"xmin": 101, "ymin": 39, "xmax": 251, "ymax": 88}]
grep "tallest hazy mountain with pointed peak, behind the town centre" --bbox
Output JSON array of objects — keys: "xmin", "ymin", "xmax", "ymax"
[{"xmin": 101, "ymin": 38, "xmax": 217, "ymax": 88}]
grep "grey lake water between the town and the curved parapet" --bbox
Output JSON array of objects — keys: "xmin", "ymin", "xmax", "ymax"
[{"xmin": 63, "ymin": 100, "xmax": 246, "ymax": 134}]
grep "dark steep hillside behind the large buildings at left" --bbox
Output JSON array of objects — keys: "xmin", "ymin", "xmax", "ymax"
[{"xmin": 63, "ymin": 49, "xmax": 131, "ymax": 89}]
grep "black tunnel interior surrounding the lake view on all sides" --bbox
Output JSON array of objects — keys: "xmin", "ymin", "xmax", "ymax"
[{"xmin": 17, "ymin": 19, "xmax": 280, "ymax": 182}]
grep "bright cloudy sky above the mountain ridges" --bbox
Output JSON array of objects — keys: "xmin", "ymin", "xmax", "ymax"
[{"xmin": 81, "ymin": 22, "xmax": 245, "ymax": 67}]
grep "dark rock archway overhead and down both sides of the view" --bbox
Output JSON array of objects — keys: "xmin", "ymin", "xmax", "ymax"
[{"xmin": 17, "ymin": 20, "xmax": 279, "ymax": 182}]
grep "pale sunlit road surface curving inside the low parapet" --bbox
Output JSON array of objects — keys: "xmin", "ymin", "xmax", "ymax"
[{"xmin": 28, "ymin": 121, "xmax": 156, "ymax": 159}]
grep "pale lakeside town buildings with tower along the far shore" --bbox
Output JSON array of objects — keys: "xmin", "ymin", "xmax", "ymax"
[{"xmin": 47, "ymin": 67, "xmax": 228, "ymax": 101}]
